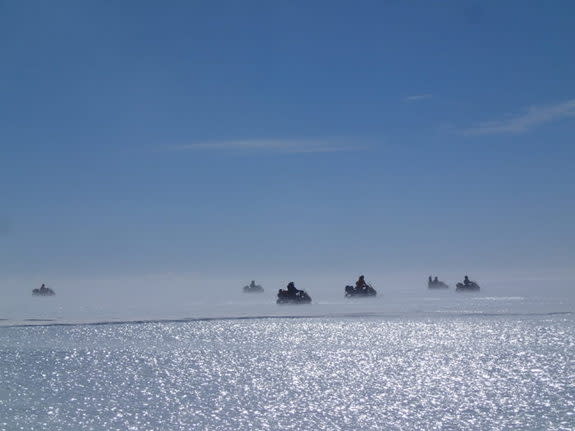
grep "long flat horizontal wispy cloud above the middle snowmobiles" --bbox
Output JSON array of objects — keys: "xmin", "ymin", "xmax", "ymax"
[{"xmin": 169, "ymin": 139, "xmax": 361, "ymax": 154}]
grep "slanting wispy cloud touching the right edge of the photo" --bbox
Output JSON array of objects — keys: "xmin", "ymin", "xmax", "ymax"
[{"xmin": 463, "ymin": 99, "xmax": 575, "ymax": 135}]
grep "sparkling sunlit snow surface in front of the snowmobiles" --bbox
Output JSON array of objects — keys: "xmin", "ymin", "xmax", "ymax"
[{"xmin": 0, "ymin": 313, "xmax": 575, "ymax": 431}]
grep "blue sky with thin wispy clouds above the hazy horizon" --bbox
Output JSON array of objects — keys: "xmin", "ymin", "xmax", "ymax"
[{"xmin": 0, "ymin": 1, "xmax": 575, "ymax": 284}]
